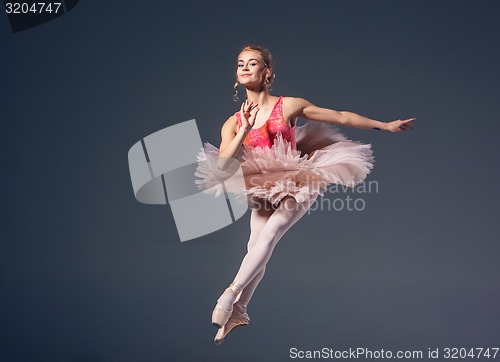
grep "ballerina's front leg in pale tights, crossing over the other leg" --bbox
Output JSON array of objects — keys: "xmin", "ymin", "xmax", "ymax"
[{"xmin": 214, "ymin": 196, "xmax": 316, "ymax": 310}]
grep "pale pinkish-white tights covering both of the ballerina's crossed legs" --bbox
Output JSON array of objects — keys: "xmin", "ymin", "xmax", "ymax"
[{"xmin": 218, "ymin": 195, "xmax": 317, "ymax": 310}]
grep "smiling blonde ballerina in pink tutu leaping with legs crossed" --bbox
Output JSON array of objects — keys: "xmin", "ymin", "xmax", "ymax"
[{"xmin": 197, "ymin": 46, "xmax": 415, "ymax": 344}]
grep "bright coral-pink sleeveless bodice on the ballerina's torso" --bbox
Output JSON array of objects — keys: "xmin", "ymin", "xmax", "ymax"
[{"xmin": 234, "ymin": 97, "xmax": 297, "ymax": 149}]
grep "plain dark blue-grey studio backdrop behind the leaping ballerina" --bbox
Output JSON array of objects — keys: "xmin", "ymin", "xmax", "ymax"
[{"xmin": 0, "ymin": 0, "xmax": 500, "ymax": 361}]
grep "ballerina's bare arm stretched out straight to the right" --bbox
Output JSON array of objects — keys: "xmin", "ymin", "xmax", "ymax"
[{"xmin": 286, "ymin": 97, "xmax": 416, "ymax": 132}]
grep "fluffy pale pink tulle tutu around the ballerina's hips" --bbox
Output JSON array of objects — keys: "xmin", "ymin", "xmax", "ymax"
[{"xmin": 195, "ymin": 121, "xmax": 374, "ymax": 205}]
